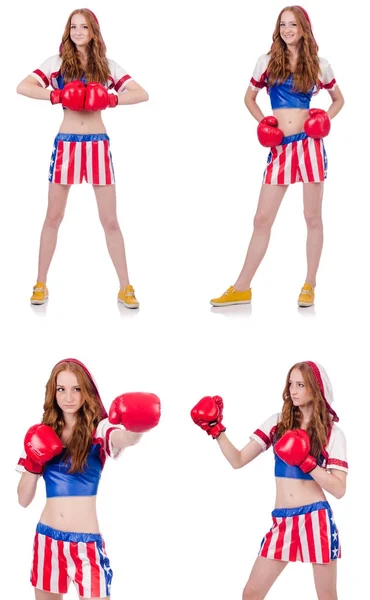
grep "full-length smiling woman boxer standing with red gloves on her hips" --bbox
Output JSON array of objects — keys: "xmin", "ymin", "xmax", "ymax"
[{"xmin": 211, "ymin": 6, "xmax": 344, "ymax": 307}]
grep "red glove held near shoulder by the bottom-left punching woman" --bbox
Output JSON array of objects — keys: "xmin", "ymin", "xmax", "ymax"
[{"xmin": 23, "ymin": 425, "xmax": 63, "ymax": 474}]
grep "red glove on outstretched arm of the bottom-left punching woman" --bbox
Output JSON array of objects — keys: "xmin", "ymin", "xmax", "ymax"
[{"xmin": 109, "ymin": 392, "xmax": 161, "ymax": 433}]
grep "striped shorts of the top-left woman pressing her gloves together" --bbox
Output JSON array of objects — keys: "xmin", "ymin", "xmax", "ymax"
[{"xmin": 49, "ymin": 133, "xmax": 115, "ymax": 185}]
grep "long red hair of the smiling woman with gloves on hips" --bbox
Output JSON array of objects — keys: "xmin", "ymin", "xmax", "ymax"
[{"xmin": 268, "ymin": 6, "xmax": 320, "ymax": 92}]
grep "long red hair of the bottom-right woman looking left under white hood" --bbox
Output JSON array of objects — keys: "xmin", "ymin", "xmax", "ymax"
[{"xmin": 275, "ymin": 362, "xmax": 333, "ymax": 459}]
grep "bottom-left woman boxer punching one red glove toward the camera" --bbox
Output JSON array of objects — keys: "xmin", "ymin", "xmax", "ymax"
[{"xmin": 17, "ymin": 359, "xmax": 160, "ymax": 600}]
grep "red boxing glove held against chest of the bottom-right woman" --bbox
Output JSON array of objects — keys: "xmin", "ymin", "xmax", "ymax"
[{"xmin": 274, "ymin": 429, "xmax": 317, "ymax": 473}]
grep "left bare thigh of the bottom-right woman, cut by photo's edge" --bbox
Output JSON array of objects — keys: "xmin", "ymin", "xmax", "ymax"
[{"xmin": 243, "ymin": 556, "xmax": 288, "ymax": 600}]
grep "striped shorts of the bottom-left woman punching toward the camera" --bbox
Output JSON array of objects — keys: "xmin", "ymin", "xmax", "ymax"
[{"xmin": 31, "ymin": 523, "xmax": 113, "ymax": 598}]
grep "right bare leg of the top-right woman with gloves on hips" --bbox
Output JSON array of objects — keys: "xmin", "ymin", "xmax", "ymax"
[{"xmin": 303, "ymin": 182, "xmax": 324, "ymax": 288}]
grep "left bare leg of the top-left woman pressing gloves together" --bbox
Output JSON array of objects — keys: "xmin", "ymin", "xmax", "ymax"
[{"xmin": 37, "ymin": 183, "xmax": 71, "ymax": 283}]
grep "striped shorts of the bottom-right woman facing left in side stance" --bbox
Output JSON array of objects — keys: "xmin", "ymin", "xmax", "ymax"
[{"xmin": 258, "ymin": 502, "xmax": 341, "ymax": 564}]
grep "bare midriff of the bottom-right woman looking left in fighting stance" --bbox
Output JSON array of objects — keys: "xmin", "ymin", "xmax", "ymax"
[{"xmin": 275, "ymin": 477, "xmax": 326, "ymax": 508}]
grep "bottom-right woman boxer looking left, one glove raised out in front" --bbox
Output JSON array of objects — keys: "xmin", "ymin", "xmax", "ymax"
[{"xmin": 191, "ymin": 361, "xmax": 348, "ymax": 600}]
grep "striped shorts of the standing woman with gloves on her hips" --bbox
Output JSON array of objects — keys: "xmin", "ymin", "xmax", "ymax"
[{"xmin": 262, "ymin": 132, "xmax": 328, "ymax": 185}]
